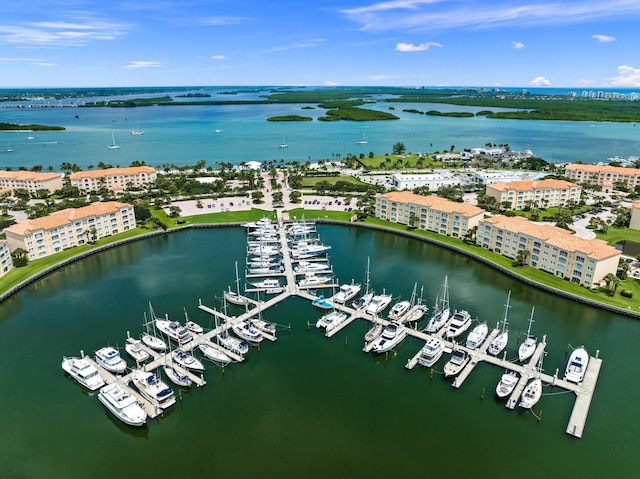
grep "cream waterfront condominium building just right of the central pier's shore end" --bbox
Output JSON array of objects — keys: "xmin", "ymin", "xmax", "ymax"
[{"xmin": 376, "ymin": 191, "xmax": 485, "ymax": 238}]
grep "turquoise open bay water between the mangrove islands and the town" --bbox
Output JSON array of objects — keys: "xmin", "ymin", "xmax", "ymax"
[{"xmin": 0, "ymin": 87, "xmax": 640, "ymax": 169}]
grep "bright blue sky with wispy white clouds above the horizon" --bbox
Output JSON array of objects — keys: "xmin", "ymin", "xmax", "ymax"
[{"xmin": 0, "ymin": 0, "xmax": 640, "ymax": 89}]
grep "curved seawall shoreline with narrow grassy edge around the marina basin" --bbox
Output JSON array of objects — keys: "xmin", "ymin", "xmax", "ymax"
[{"xmin": 0, "ymin": 218, "xmax": 640, "ymax": 319}]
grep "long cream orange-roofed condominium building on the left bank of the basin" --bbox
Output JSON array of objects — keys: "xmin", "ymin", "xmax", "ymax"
[{"xmin": 4, "ymin": 201, "xmax": 136, "ymax": 260}]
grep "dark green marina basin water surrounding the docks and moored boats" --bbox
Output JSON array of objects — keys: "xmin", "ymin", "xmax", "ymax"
[{"xmin": 0, "ymin": 226, "xmax": 640, "ymax": 479}]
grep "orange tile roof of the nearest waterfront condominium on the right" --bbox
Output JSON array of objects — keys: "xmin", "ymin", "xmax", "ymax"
[{"xmin": 483, "ymin": 216, "xmax": 620, "ymax": 260}]
